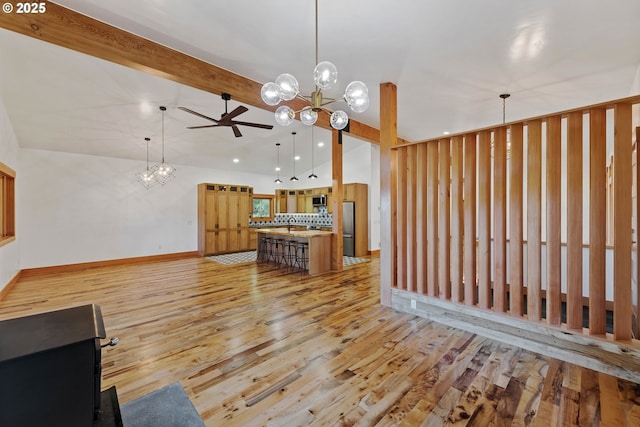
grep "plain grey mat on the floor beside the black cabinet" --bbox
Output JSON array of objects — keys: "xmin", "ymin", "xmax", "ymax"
[{"xmin": 120, "ymin": 382, "xmax": 204, "ymax": 427}]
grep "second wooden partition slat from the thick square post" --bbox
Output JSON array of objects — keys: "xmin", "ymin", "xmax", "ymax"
[{"xmin": 406, "ymin": 145, "xmax": 417, "ymax": 292}]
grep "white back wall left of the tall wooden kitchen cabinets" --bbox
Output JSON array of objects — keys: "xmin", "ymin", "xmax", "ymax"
[{"xmin": 16, "ymin": 149, "xmax": 273, "ymax": 269}]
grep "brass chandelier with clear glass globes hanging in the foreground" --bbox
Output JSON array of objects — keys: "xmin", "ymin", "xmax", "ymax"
[{"xmin": 260, "ymin": 0, "xmax": 369, "ymax": 130}]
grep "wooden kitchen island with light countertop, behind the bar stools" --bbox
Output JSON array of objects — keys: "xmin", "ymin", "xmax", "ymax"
[{"xmin": 257, "ymin": 227, "xmax": 333, "ymax": 275}]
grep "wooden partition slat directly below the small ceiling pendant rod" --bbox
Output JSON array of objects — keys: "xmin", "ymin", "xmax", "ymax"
[{"xmin": 493, "ymin": 127, "xmax": 507, "ymax": 313}]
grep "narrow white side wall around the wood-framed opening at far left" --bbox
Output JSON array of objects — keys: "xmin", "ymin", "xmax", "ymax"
[{"xmin": 0, "ymin": 100, "xmax": 22, "ymax": 290}]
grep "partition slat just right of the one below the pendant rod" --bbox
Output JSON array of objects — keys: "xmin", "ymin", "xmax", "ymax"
[{"xmin": 509, "ymin": 123, "xmax": 524, "ymax": 316}]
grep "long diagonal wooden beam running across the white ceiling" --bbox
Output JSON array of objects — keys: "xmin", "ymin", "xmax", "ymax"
[{"xmin": 0, "ymin": 2, "xmax": 390, "ymax": 144}]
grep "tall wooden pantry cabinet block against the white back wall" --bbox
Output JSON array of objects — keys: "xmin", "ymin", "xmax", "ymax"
[{"xmin": 198, "ymin": 183, "xmax": 256, "ymax": 256}]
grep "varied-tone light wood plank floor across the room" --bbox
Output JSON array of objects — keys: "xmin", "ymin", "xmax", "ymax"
[{"xmin": 0, "ymin": 258, "xmax": 640, "ymax": 427}]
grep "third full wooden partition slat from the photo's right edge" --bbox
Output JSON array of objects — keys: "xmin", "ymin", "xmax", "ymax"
[{"xmin": 567, "ymin": 113, "xmax": 584, "ymax": 330}]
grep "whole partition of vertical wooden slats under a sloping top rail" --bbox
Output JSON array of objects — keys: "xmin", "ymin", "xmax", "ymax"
[{"xmin": 394, "ymin": 96, "xmax": 640, "ymax": 348}]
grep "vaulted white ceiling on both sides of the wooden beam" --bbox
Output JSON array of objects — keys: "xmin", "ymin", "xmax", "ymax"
[{"xmin": 0, "ymin": 0, "xmax": 640, "ymax": 174}]
